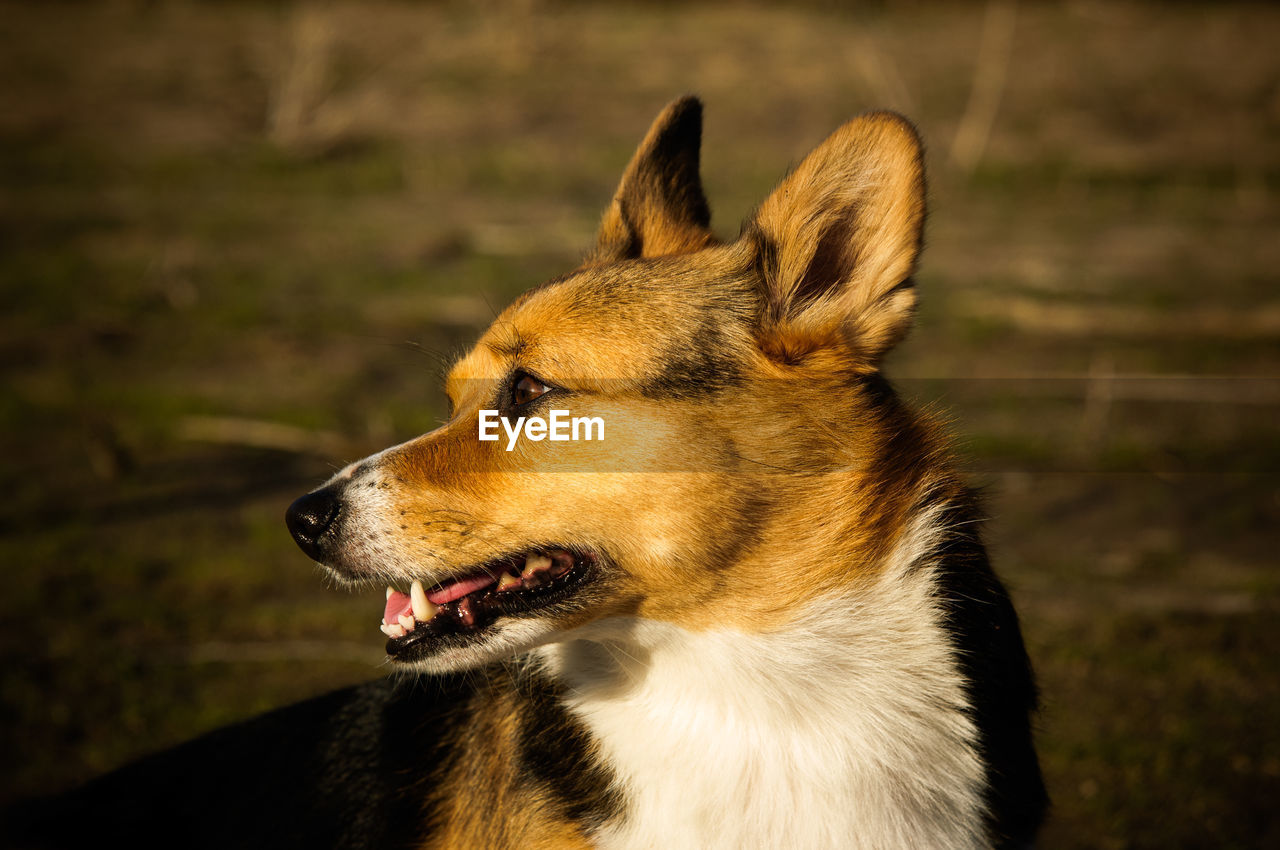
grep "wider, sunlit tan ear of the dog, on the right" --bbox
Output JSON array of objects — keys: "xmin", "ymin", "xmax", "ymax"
[{"xmin": 744, "ymin": 113, "xmax": 924, "ymax": 370}]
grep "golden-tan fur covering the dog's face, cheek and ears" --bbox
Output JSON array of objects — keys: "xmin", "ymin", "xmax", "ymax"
[{"xmin": 371, "ymin": 104, "xmax": 942, "ymax": 629}]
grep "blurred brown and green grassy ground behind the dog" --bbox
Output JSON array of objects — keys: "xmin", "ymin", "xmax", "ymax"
[{"xmin": 0, "ymin": 0, "xmax": 1280, "ymax": 849}]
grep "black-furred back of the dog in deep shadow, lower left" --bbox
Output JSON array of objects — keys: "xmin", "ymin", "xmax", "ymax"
[{"xmin": 6, "ymin": 677, "xmax": 476, "ymax": 847}]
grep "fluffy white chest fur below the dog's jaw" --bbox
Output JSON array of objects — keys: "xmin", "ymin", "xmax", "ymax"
[{"xmin": 544, "ymin": 558, "xmax": 987, "ymax": 850}]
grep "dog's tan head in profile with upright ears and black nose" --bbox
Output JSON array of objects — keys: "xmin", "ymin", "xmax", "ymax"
[{"xmin": 288, "ymin": 99, "xmax": 932, "ymax": 671}]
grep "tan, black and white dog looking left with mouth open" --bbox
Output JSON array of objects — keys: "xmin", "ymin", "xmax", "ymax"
[{"xmin": 12, "ymin": 97, "xmax": 1047, "ymax": 850}]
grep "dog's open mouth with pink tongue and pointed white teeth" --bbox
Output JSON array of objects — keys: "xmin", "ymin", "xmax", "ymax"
[{"xmin": 381, "ymin": 548, "xmax": 595, "ymax": 658}]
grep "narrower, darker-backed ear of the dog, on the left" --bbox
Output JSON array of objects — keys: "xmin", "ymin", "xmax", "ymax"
[{"xmin": 585, "ymin": 97, "xmax": 714, "ymax": 265}]
